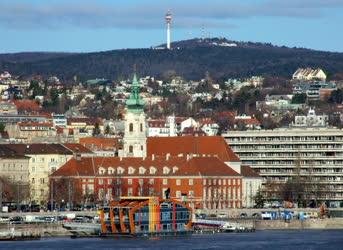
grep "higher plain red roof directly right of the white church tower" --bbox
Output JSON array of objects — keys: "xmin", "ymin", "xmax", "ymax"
[{"xmin": 147, "ymin": 136, "xmax": 240, "ymax": 162}]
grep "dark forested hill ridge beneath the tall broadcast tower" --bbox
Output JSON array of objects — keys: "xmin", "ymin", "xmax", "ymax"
[{"xmin": 0, "ymin": 38, "xmax": 343, "ymax": 80}]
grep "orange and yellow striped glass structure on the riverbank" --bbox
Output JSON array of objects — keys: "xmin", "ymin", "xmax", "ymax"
[{"xmin": 100, "ymin": 197, "xmax": 192, "ymax": 235}]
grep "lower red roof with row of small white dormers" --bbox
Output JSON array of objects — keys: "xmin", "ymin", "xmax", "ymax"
[{"xmin": 51, "ymin": 157, "xmax": 240, "ymax": 177}]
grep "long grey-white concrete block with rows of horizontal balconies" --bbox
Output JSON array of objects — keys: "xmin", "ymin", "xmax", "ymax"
[{"xmin": 223, "ymin": 128, "xmax": 343, "ymax": 205}]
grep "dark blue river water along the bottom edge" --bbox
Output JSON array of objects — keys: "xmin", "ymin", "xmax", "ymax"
[{"xmin": 0, "ymin": 230, "xmax": 343, "ymax": 250}]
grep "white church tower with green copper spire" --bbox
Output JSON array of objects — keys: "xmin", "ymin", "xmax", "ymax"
[{"xmin": 123, "ymin": 73, "xmax": 147, "ymax": 157}]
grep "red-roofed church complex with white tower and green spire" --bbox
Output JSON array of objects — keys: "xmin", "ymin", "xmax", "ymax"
[{"xmin": 50, "ymin": 75, "xmax": 262, "ymax": 209}]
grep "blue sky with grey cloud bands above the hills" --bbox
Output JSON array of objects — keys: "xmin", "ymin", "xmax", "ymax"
[{"xmin": 0, "ymin": 0, "xmax": 343, "ymax": 53}]
